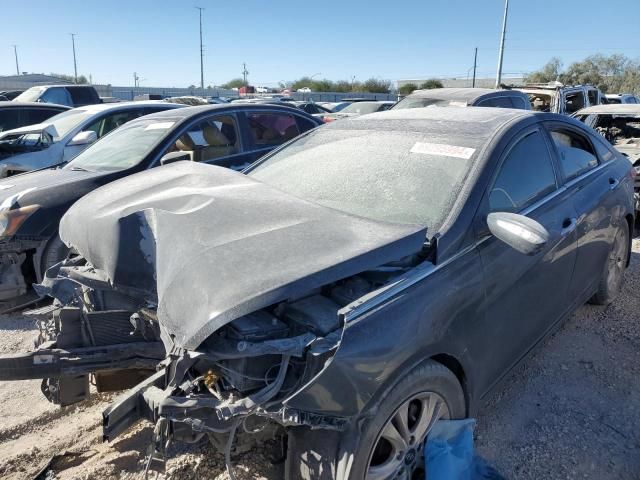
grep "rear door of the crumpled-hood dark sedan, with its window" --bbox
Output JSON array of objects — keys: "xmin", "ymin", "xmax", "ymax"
[{"xmin": 545, "ymin": 122, "xmax": 620, "ymax": 300}]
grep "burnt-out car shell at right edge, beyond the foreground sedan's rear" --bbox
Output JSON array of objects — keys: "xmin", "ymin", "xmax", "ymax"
[{"xmin": 575, "ymin": 103, "xmax": 640, "ymax": 223}]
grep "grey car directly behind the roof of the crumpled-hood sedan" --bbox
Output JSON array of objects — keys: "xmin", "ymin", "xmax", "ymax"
[{"xmin": 393, "ymin": 88, "xmax": 531, "ymax": 110}]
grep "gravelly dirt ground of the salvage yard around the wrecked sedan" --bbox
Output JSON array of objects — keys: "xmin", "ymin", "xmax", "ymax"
[{"xmin": 0, "ymin": 241, "xmax": 640, "ymax": 480}]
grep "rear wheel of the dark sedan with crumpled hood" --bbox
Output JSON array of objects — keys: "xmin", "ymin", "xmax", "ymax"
[{"xmin": 589, "ymin": 220, "xmax": 631, "ymax": 305}]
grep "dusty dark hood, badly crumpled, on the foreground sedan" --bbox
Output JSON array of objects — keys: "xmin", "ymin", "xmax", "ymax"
[{"xmin": 60, "ymin": 162, "xmax": 426, "ymax": 349}]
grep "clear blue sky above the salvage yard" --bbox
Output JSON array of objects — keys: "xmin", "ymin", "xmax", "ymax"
[{"xmin": 0, "ymin": 0, "xmax": 640, "ymax": 86}]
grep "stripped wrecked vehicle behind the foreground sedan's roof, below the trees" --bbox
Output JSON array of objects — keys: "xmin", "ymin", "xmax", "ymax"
[{"xmin": 513, "ymin": 82, "xmax": 606, "ymax": 115}]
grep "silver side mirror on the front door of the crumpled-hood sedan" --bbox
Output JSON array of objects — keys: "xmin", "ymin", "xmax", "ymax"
[{"xmin": 487, "ymin": 212, "xmax": 549, "ymax": 255}]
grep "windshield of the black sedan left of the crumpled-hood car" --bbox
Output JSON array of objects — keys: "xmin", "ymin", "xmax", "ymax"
[{"xmin": 64, "ymin": 120, "xmax": 175, "ymax": 172}]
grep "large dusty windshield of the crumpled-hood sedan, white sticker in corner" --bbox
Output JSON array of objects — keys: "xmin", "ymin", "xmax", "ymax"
[{"xmin": 249, "ymin": 125, "xmax": 475, "ymax": 232}]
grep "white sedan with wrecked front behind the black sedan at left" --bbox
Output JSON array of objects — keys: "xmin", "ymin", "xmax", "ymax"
[{"xmin": 0, "ymin": 101, "xmax": 182, "ymax": 178}]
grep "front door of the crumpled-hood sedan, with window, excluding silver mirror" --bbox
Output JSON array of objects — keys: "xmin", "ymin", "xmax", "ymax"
[{"xmin": 469, "ymin": 126, "xmax": 577, "ymax": 385}]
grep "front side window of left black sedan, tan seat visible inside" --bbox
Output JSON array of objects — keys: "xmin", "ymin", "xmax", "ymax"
[{"xmin": 169, "ymin": 115, "xmax": 240, "ymax": 162}]
